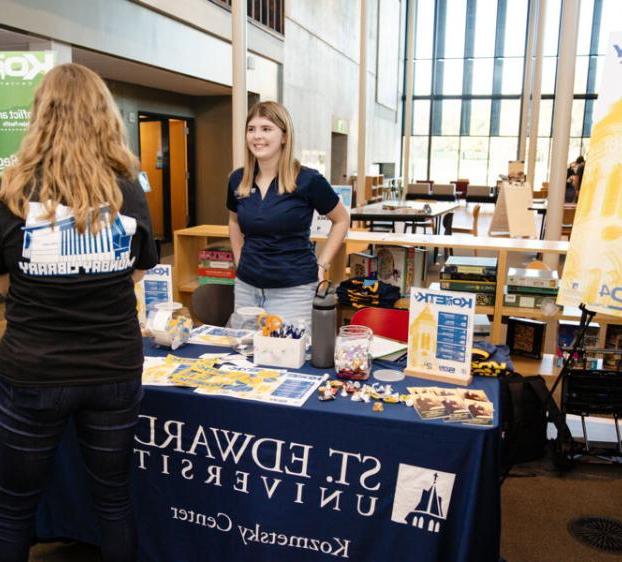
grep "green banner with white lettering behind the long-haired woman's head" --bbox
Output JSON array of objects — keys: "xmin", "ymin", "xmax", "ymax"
[{"xmin": 0, "ymin": 51, "xmax": 56, "ymax": 174}]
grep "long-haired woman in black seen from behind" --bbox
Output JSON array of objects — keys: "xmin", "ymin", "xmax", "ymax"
[{"xmin": 0, "ymin": 64, "xmax": 157, "ymax": 562}]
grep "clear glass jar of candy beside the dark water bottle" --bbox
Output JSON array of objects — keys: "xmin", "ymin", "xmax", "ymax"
[{"xmin": 335, "ymin": 325, "xmax": 373, "ymax": 381}]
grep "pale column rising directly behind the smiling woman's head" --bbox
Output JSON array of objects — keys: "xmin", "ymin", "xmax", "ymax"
[{"xmin": 231, "ymin": 0, "xmax": 248, "ymax": 168}]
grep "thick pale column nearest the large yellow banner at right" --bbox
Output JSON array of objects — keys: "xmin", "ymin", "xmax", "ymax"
[{"xmin": 544, "ymin": 0, "xmax": 581, "ymax": 268}]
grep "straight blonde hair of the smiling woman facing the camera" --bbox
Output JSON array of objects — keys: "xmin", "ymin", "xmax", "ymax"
[{"xmin": 236, "ymin": 101, "xmax": 300, "ymax": 197}]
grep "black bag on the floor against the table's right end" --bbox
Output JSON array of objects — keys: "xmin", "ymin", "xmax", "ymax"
[{"xmin": 499, "ymin": 373, "xmax": 551, "ymax": 474}]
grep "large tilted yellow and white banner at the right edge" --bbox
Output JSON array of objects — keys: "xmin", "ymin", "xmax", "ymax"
[{"xmin": 557, "ymin": 32, "xmax": 622, "ymax": 316}]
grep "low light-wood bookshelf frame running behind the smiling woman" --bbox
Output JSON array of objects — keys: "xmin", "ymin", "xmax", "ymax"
[{"xmin": 173, "ymin": 225, "xmax": 622, "ymax": 344}]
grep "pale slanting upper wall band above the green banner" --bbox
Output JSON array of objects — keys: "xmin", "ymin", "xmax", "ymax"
[{"xmin": 0, "ymin": 0, "xmax": 232, "ymax": 86}]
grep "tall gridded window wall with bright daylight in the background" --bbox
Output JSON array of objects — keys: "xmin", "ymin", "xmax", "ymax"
[{"xmin": 410, "ymin": 0, "xmax": 622, "ymax": 185}]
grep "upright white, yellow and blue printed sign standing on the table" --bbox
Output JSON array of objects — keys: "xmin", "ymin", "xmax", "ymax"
[{"xmin": 404, "ymin": 287, "xmax": 476, "ymax": 385}]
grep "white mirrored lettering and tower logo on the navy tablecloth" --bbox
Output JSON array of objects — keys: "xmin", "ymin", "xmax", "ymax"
[{"xmin": 134, "ymin": 415, "xmax": 455, "ymax": 560}]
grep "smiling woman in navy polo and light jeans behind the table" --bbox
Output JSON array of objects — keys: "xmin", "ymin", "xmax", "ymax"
[{"xmin": 227, "ymin": 102, "xmax": 350, "ymax": 328}]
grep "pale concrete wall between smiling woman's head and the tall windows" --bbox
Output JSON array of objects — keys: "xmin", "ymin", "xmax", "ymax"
[{"xmin": 283, "ymin": 0, "xmax": 405, "ymax": 176}]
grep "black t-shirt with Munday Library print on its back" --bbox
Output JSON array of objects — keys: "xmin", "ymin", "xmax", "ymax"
[{"xmin": 0, "ymin": 180, "xmax": 157, "ymax": 386}]
